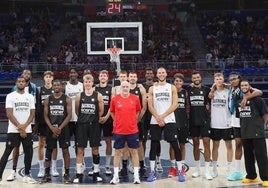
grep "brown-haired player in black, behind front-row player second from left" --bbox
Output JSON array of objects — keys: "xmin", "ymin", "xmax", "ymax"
[{"xmin": 36, "ymin": 71, "xmax": 59, "ymax": 178}]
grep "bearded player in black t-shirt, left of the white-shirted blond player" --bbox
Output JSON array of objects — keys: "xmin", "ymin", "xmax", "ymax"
[{"xmin": 187, "ymin": 71, "xmax": 213, "ymax": 180}]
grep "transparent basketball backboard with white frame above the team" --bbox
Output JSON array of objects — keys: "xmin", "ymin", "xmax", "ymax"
[{"xmin": 87, "ymin": 22, "xmax": 142, "ymax": 55}]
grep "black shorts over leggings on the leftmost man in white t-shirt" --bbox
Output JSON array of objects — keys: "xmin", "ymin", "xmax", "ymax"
[{"xmin": 6, "ymin": 133, "xmax": 33, "ymax": 147}]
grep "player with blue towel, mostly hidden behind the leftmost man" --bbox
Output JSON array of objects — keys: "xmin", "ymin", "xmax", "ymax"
[{"xmin": 7, "ymin": 69, "xmax": 38, "ymax": 181}]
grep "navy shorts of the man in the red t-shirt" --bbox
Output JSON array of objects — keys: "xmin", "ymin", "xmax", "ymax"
[{"xmin": 113, "ymin": 133, "xmax": 139, "ymax": 149}]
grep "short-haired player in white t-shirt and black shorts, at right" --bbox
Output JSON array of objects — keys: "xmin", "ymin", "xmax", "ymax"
[{"xmin": 211, "ymin": 73, "xmax": 234, "ymax": 178}]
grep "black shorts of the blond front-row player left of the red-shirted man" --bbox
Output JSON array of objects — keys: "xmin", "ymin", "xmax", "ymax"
[{"xmin": 76, "ymin": 122, "xmax": 101, "ymax": 148}]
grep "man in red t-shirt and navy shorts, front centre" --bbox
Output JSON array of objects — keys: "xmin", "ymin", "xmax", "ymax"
[{"xmin": 110, "ymin": 81, "xmax": 141, "ymax": 184}]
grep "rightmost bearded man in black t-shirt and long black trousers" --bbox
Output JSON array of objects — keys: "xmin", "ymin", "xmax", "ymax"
[{"xmin": 235, "ymin": 80, "xmax": 268, "ymax": 187}]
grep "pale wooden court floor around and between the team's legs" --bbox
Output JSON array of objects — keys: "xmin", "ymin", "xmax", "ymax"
[{"xmin": 0, "ymin": 139, "xmax": 268, "ymax": 188}]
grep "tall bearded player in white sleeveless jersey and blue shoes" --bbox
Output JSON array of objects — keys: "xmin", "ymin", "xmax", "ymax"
[{"xmin": 147, "ymin": 67, "xmax": 185, "ymax": 182}]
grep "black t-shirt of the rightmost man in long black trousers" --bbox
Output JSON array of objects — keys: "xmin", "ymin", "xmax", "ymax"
[{"xmin": 236, "ymin": 97, "xmax": 268, "ymax": 139}]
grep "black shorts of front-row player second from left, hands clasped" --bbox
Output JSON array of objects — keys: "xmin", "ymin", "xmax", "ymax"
[{"xmin": 46, "ymin": 125, "xmax": 70, "ymax": 149}]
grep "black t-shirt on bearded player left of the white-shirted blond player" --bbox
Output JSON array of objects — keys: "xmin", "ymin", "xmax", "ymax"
[{"xmin": 187, "ymin": 86, "xmax": 210, "ymax": 126}]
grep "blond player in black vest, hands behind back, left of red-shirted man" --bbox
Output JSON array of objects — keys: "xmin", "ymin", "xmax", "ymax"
[{"xmin": 73, "ymin": 74, "xmax": 104, "ymax": 183}]
